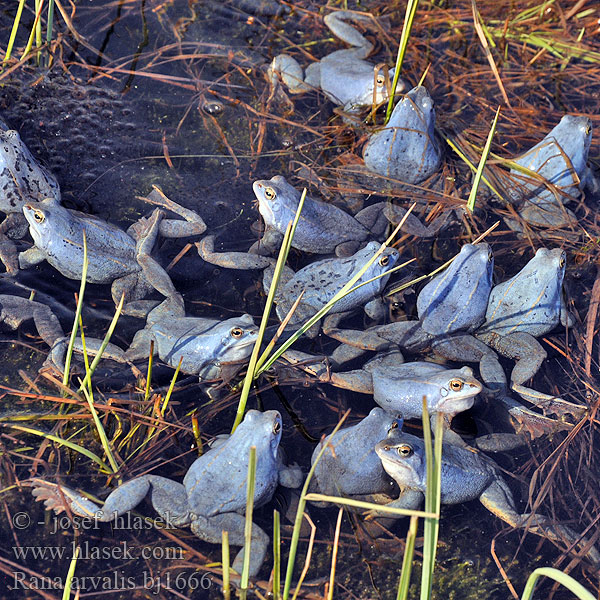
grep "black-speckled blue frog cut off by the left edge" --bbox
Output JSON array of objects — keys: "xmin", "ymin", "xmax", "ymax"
[{"xmin": 0, "ymin": 129, "xmax": 60, "ymax": 214}]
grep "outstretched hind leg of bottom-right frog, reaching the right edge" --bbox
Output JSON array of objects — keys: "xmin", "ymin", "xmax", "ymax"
[{"xmin": 479, "ymin": 478, "xmax": 600, "ymax": 565}]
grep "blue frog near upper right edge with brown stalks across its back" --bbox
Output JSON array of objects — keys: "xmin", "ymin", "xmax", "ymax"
[{"xmin": 510, "ymin": 115, "xmax": 593, "ymax": 227}]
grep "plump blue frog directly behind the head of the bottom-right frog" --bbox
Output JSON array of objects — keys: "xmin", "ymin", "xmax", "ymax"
[{"xmin": 311, "ymin": 408, "xmax": 398, "ymax": 504}]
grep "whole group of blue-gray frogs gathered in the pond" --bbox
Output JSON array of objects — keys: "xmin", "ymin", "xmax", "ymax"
[{"xmin": 0, "ymin": 11, "xmax": 600, "ymax": 575}]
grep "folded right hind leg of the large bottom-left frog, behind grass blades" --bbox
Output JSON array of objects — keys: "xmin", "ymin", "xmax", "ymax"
[{"xmin": 190, "ymin": 513, "xmax": 269, "ymax": 577}]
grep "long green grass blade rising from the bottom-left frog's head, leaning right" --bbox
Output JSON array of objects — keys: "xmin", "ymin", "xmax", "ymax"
[{"xmin": 231, "ymin": 188, "xmax": 306, "ymax": 433}]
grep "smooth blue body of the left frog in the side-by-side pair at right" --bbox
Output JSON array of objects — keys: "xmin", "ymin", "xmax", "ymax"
[{"xmin": 417, "ymin": 243, "xmax": 494, "ymax": 335}]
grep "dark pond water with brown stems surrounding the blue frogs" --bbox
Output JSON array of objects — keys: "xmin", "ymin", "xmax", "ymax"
[{"xmin": 0, "ymin": 0, "xmax": 600, "ymax": 599}]
